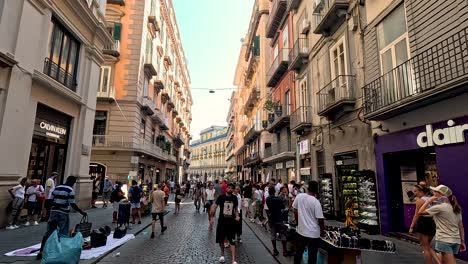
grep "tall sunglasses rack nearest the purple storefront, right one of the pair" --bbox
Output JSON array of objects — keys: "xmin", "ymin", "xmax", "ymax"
[{"xmin": 356, "ymin": 170, "xmax": 379, "ymax": 234}]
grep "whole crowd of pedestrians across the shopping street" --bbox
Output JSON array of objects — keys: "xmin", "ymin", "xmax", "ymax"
[{"xmin": 3, "ymin": 173, "xmax": 466, "ymax": 264}]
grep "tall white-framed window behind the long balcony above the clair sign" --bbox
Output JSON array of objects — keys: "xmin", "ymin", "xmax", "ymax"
[{"xmin": 377, "ymin": 5, "xmax": 413, "ymax": 100}]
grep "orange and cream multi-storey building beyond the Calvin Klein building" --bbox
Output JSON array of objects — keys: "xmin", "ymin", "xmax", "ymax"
[{"xmin": 89, "ymin": 0, "xmax": 192, "ymax": 188}]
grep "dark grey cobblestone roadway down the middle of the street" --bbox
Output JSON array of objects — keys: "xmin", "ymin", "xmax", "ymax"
[{"xmin": 99, "ymin": 203, "xmax": 278, "ymax": 264}]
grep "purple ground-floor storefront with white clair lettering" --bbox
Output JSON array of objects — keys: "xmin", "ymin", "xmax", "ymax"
[{"xmin": 375, "ymin": 115, "xmax": 468, "ymax": 259}]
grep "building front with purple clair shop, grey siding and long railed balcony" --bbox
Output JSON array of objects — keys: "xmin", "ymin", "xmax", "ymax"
[{"xmin": 363, "ymin": 1, "xmax": 468, "ymax": 259}]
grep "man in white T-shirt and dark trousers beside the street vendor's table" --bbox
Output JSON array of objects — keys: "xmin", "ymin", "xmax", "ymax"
[{"xmin": 292, "ymin": 181, "xmax": 325, "ymax": 264}]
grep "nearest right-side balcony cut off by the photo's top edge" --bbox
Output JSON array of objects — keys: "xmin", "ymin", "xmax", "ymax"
[{"xmin": 314, "ymin": 0, "xmax": 349, "ymax": 35}]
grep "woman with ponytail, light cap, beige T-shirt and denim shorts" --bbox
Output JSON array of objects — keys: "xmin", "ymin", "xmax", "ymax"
[{"xmin": 419, "ymin": 185, "xmax": 466, "ymax": 264}]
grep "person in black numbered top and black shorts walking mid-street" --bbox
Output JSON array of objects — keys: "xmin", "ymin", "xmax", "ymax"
[{"xmin": 210, "ymin": 184, "xmax": 240, "ymax": 264}]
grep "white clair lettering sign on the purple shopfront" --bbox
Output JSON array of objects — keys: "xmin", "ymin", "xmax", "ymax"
[{"xmin": 416, "ymin": 120, "xmax": 468, "ymax": 148}]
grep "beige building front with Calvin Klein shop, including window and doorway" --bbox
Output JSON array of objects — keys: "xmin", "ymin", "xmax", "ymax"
[{"xmin": 0, "ymin": 0, "xmax": 111, "ymax": 226}]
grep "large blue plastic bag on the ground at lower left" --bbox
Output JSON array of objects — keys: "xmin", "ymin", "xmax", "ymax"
[{"xmin": 41, "ymin": 230, "xmax": 83, "ymax": 264}]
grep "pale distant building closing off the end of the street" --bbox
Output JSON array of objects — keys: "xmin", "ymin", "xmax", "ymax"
[{"xmin": 188, "ymin": 126, "xmax": 228, "ymax": 182}]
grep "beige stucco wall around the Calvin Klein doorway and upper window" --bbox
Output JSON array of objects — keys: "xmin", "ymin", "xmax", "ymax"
[{"xmin": 0, "ymin": 0, "xmax": 110, "ymax": 226}]
